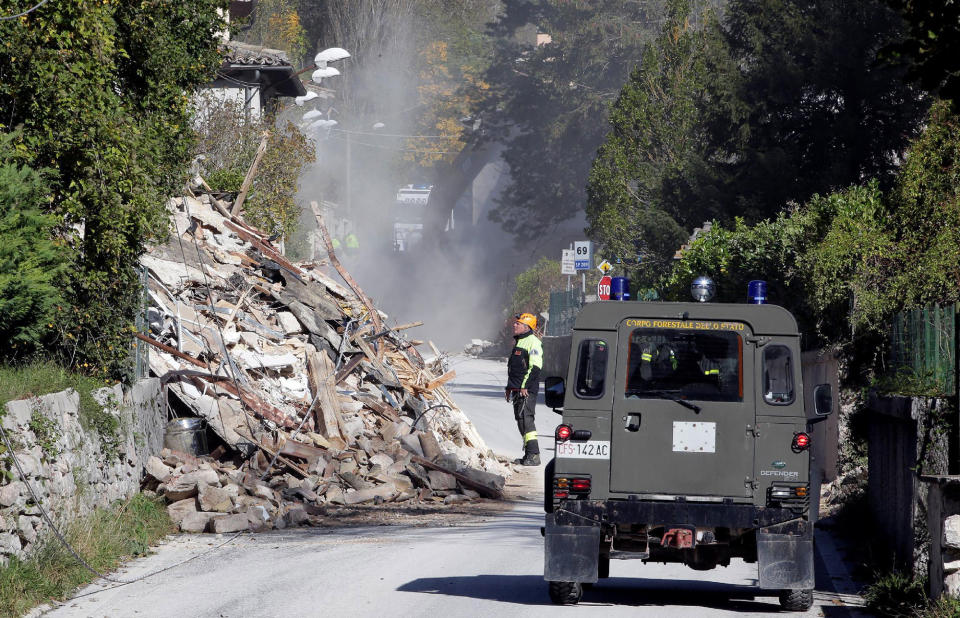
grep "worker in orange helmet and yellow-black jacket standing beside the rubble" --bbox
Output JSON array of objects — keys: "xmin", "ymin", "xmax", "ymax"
[{"xmin": 505, "ymin": 313, "xmax": 543, "ymax": 466}]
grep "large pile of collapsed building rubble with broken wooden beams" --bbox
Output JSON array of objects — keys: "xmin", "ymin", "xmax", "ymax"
[{"xmin": 137, "ymin": 179, "xmax": 509, "ymax": 532}]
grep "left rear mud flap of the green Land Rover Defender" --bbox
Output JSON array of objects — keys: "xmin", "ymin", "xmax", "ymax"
[{"xmin": 543, "ymin": 513, "xmax": 600, "ymax": 584}]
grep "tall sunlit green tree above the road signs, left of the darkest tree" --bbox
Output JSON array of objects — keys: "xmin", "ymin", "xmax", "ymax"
[{"xmin": 587, "ymin": 0, "xmax": 719, "ymax": 283}]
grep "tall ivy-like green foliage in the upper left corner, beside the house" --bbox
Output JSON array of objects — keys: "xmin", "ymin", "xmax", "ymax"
[{"xmin": 0, "ymin": 0, "xmax": 226, "ymax": 373}]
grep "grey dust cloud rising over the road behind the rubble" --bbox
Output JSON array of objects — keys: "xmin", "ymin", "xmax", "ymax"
[{"xmin": 286, "ymin": 8, "xmax": 584, "ymax": 352}]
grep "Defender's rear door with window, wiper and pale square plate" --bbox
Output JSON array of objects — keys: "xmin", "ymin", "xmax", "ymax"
[{"xmin": 610, "ymin": 318, "xmax": 755, "ymax": 500}]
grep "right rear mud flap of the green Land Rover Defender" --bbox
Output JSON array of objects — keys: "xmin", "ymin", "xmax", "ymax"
[{"xmin": 757, "ymin": 531, "xmax": 814, "ymax": 590}]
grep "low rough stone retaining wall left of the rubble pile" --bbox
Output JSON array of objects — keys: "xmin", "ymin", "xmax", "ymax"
[{"xmin": 0, "ymin": 378, "xmax": 166, "ymax": 564}]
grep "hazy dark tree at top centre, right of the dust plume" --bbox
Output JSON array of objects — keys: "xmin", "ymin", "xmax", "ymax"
[{"xmin": 478, "ymin": 0, "xmax": 703, "ymax": 238}]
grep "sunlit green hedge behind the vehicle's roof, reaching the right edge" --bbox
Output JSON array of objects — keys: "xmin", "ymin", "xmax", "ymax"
[{"xmin": 661, "ymin": 102, "xmax": 960, "ymax": 361}]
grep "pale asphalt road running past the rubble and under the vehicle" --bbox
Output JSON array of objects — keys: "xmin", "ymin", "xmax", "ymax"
[{"xmin": 49, "ymin": 359, "xmax": 863, "ymax": 618}]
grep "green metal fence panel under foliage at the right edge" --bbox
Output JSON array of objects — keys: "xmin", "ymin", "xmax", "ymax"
[{"xmin": 890, "ymin": 305, "xmax": 958, "ymax": 396}]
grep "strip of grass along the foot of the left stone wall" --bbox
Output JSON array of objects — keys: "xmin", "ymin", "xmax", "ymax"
[{"xmin": 0, "ymin": 494, "xmax": 174, "ymax": 616}]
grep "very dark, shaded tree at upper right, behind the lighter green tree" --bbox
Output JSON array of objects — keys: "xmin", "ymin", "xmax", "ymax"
[{"xmin": 708, "ymin": 0, "xmax": 926, "ymax": 221}]
